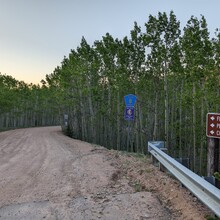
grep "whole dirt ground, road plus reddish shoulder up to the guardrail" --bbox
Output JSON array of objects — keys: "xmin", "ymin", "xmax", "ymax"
[{"xmin": 0, "ymin": 127, "xmax": 214, "ymax": 220}]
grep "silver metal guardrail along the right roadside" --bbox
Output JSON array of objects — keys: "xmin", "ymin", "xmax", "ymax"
[{"xmin": 148, "ymin": 141, "xmax": 220, "ymax": 217}]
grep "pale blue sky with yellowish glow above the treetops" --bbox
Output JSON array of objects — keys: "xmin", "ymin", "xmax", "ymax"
[{"xmin": 0, "ymin": 0, "xmax": 220, "ymax": 83}]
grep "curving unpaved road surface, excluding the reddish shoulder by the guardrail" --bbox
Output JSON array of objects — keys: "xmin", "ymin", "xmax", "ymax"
[{"xmin": 0, "ymin": 127, "xmax": 170, "ymax": 220}]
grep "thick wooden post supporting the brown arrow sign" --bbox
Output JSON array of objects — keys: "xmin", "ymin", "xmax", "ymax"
[{"xmin": 207, "ymin": 137, "xmax": 219, "ymax": 176}]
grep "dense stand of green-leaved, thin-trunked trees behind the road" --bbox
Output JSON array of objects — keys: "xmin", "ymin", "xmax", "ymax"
[{"xmin": 0, "ymin": 11, "xmax": 220, "ymax": 175}]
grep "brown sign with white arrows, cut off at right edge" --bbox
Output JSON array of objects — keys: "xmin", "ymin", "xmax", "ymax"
[{"xmin": 206, "ymin": 113, "xmax": 220, "ymax": 138}]
